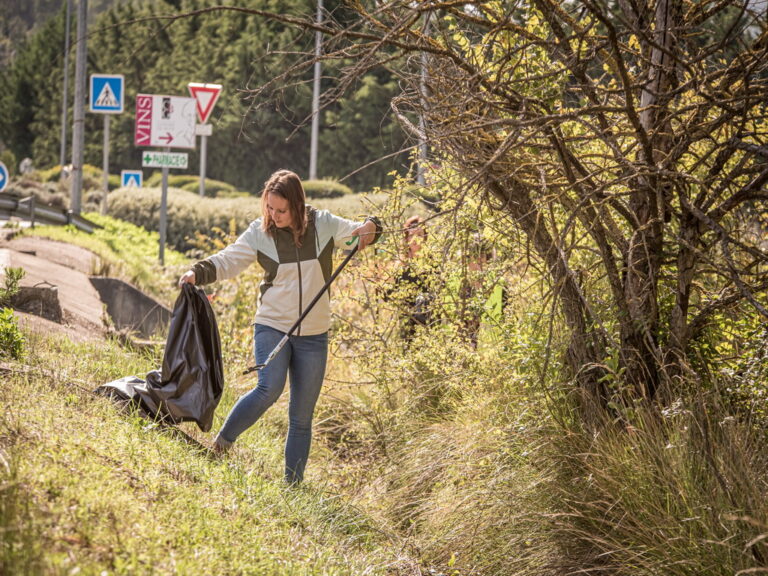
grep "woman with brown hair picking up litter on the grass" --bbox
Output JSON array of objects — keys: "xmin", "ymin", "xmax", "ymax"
[{"xmin": 179, "ymin": 170, "xmax": 381, "ymax": 484}]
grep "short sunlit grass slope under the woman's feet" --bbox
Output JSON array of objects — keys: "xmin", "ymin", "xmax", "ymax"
[{"xmin": 0, "ymin": 334, "xmax": 412, "ymax": 575}]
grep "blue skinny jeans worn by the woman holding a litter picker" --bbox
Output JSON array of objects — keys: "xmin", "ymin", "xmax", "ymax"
[{"xmin": 217, "ymin": 324, "xmax": 328, "ymax": 483}]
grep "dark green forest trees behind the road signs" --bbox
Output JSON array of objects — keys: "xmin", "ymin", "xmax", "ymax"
[{"xmin": 0, "ymin": 0, "xmax": 412, "ymax": 193}]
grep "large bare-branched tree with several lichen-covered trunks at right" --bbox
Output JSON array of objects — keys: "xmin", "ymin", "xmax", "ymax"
[{"xmin": 192, "ymin": 0, "xmax": 768, "ymax": 401}]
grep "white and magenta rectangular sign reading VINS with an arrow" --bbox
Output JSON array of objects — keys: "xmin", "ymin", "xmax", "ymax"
[{"xmin": 134, "ymin": 94, "xmax": 196, "ymax": 148}]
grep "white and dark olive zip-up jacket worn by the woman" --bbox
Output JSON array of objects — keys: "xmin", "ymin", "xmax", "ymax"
[{"xmin": 192, "ymin": 206, "xmax": 381, "ymax": 336}]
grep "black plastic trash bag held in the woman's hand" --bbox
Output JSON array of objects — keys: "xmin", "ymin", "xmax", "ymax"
[{"xmin": 96, "ymin": 283, "xmax": 224, "ymax": 432}]
